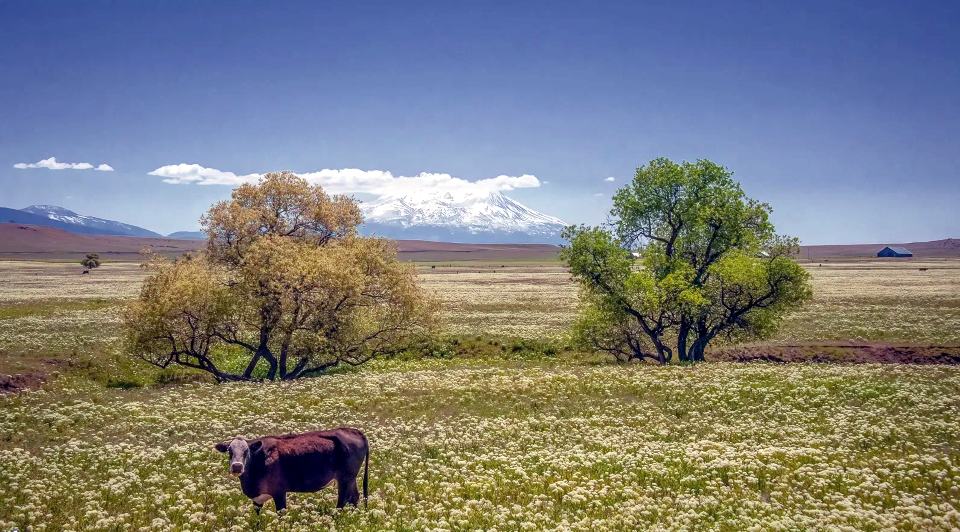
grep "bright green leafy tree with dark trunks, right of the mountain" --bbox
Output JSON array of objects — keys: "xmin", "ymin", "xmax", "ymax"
[{"xmin": 561, "ymin": 158, "xmax": 812, "ymax": 364}]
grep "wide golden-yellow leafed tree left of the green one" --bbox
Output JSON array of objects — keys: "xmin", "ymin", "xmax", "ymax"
[{"xmin": 124, "ymin": 172, "xmax": 437, "ymax": 381}]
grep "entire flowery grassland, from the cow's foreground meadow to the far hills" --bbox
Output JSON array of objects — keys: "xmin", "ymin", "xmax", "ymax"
[{"xmin": 0, "ymin": 260, "xmax": 960, "ymax": 532}]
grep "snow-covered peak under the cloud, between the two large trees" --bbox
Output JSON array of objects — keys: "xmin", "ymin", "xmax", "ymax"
[{"xmin": 360, "ymin": 190, "xmax": 566, "ymax": 244}]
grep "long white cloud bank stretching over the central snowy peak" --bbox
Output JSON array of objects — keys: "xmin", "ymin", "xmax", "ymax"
[{"xmin": 149, "ymin": 164, "xmax": 541, "ymax": 195}]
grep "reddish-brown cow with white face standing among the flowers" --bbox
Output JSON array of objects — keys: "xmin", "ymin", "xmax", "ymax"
[{"xmin": 215, "ymin": 427, "xmax": 370, "ymax": 513}]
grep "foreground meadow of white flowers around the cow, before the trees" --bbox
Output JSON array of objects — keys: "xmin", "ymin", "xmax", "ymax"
[{"xmin": 0, "ymin": 361, "xmax": 960, "ymax": 531}]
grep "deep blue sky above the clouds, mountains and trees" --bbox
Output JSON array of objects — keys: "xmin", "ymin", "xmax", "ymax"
[{"xmin": 0, "ymin": 1, "xmax": 960, "ymax": 244}]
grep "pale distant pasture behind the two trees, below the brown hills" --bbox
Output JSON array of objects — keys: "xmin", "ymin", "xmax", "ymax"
[{"xmin": 0, "ymin": 259, "xmax": 960, "ymax": 372}]
